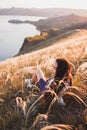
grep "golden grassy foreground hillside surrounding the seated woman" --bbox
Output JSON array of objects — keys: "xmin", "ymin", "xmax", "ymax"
[{"xmin": 0, "ymin": 29, "xmax": 87, "ymax": 130}]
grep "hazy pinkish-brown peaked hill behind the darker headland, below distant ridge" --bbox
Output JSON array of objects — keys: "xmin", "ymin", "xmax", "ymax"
[{"xmin": 30, "ymin": 14, "xmax": 87, "ymax": 31}]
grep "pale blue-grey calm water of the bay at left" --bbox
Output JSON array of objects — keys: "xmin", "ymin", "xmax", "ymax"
[{"xmin": 0, "ymin": 16, "xmax": 44, "ymax": 61}]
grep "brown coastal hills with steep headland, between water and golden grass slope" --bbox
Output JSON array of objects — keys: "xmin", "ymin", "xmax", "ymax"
[{"xmin": 18, "ymin": 15, "xmax": 87, "ymax": 55}]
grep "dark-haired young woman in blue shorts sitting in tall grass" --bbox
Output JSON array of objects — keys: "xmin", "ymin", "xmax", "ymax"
[{"xmin": 25, "ymin": 58, "xmax": 72, "ymax": 93}]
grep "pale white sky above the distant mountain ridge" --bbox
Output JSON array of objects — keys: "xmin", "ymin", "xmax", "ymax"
[{"xmin": 0, "ymin": 0, "xmax": 87, "ymax": 9}]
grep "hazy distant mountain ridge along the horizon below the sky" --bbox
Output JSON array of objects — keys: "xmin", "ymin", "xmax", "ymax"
[{"xmin": 0, "ymin": 7, "xmax": 87, "ymax": 17}]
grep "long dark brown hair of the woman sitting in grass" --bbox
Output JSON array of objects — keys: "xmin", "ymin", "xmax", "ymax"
[{"xmin": 55, "ymin": 58, "xmax": 72, "ymax": 84}]
